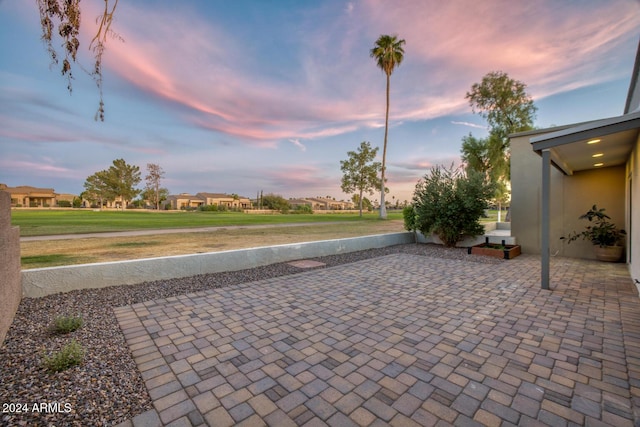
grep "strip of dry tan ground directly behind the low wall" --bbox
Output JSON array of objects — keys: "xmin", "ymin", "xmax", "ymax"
[{"xmin": 20, "ymin": 220, "xmax": 405, "ymax": 269}]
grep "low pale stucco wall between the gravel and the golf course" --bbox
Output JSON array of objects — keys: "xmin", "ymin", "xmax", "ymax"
[{"xmin": 22, "ymin": 232, "xmax": 415, "ymax": 298}]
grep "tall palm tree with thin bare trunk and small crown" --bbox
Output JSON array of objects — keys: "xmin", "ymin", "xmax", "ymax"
[{"xmin": 370, "ymin": 34, "xmax": 405, "ymax": 219}]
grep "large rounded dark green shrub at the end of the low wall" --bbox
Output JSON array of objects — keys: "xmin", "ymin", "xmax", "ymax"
[{"xmin": 405, "ymin": 166, "xmax": 494, "ymax": 247}]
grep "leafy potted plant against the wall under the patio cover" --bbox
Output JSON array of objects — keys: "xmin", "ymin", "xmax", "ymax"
[{"xmin": 561, "ymin": 205, "xmax": 627, "ymax": 262}]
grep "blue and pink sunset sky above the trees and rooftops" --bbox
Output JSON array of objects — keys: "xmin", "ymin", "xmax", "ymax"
[{"xmin": 0, "ymin": 0, "xmax": 640, "ymax": 206}]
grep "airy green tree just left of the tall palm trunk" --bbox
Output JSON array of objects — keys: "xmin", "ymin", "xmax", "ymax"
[{"xmin": 340, "ymin": 141, "xmax": 381, "ymax": 216}]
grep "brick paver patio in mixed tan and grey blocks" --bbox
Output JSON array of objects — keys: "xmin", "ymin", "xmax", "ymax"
[{"xmin": 116, "ymin": 254, "xmax": 640, "ymax": 427}]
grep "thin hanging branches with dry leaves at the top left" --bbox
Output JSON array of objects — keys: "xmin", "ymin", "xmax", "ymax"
[{"xmin": 36, "ymin": 0, "xmax": 118, "ymax": 121}]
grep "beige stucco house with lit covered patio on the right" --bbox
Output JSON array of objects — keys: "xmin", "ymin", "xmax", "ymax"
[{"xmin": 510, "ymin": 40, "xmax": 640, "ymax": 289}]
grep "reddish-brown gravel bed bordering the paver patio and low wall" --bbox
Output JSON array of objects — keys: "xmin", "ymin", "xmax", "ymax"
[{"xmin": 0, "ymin": 244, "xmax": 503, "ymax": 426}]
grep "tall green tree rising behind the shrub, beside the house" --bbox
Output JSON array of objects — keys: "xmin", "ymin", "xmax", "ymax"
[{"xmin": 462, "ymin": 71, "xmax": 537, "ymax": 221}]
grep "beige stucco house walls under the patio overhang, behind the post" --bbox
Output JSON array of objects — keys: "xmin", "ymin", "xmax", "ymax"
[{"xmin": 511, "ymin": 130, "xmax": 624, "ymax": 259}]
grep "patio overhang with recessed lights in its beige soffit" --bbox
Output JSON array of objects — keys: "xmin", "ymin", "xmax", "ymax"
[{"xmin": 530, "ymin": 111, "xmax": 640, "ymax": 175}]
